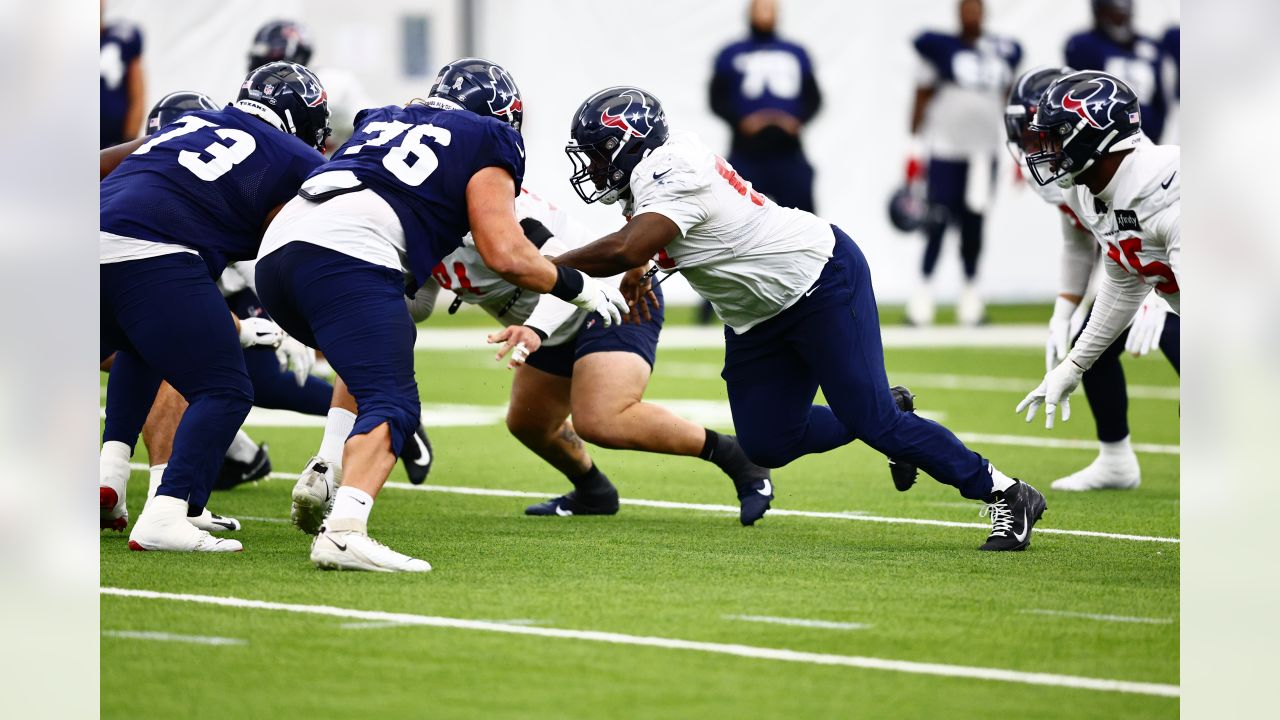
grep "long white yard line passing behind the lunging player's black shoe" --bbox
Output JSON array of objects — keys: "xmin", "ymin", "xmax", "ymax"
[{"xmin": 129, "ymin": 462, "xmax": 1181, "ymax": 544}]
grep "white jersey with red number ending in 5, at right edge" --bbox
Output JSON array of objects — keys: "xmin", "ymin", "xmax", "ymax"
[{"xmin": 1062, "ymin": 141, "xmax": 1181, "ymax": 311}]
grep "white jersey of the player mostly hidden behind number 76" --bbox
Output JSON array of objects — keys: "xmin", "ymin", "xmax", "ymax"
[{"xmin": 419, "ymin": 190, "xmax": 599, "ymax": 347}]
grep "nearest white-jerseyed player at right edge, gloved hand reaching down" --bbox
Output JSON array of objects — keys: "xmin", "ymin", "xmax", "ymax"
[{"xmin": 1016, "ymin": 70, "xmax": 1181, "ymax": 428}]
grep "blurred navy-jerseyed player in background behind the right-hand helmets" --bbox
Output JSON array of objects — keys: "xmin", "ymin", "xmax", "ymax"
[{"xmin": 1065, "ymin": 0, "xmax": 1169, "ymax": 142}]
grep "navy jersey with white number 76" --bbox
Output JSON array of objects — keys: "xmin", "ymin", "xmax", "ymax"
[{"xmin": 320, "ymin": 104, "xmax": 525, "ymax": 292}]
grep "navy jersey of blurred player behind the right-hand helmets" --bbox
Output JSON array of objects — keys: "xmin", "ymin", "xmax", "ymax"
[{"xmin": 1066, "ymin": 29, "xmax": 1166, "ymax": 142}]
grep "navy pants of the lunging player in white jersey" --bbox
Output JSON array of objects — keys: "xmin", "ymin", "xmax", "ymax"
[{"xmin": 722, "ymin": 227, "xmax": 992, "ymax": 500}]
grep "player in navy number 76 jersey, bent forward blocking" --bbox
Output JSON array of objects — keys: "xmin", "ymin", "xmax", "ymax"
[{"xmin": 257, "ymin": 58, "xmax": 627, "ymax": 573}]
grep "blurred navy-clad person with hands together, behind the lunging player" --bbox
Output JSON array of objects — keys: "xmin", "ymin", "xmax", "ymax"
[{"xmin": 699, "ymin": 0, "xmax": 822, "ymax": 323}]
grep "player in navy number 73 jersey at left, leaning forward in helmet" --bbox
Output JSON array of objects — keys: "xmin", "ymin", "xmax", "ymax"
[{"xmin": 100, "ymin": 63, "xmax": 329, "ymax": 552}]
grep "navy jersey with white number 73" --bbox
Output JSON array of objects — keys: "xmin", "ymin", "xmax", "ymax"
[{"xmin": 100, "ymin": 105, "xmax": 324, "ymax": 278}]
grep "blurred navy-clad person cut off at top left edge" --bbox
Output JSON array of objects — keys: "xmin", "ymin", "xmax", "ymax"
[{"xmin": 97, "ymin": 3, "xmax": 147, "ymax": 149}]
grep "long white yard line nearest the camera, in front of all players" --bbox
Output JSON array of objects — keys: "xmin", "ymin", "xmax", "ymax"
[{"xmin": 99, "ymin": 588, "xmax": 1181, "ymax": 697}]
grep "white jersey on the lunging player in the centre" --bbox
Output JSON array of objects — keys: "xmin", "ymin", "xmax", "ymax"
[{"xmin": 623, "ymin": 132, "xmax": 836, "ymax": 333}]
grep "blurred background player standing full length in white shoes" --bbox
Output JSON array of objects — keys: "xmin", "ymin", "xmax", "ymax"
[{"xmin": 906, "ymin": 0, "xmax": 1023, "ymax": 325}]
